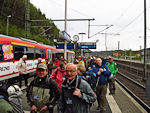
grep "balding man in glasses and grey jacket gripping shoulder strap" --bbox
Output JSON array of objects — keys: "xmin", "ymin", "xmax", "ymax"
[{"xmin": 60, "ymin": 63, "xmax": 96, "ymax": 113}]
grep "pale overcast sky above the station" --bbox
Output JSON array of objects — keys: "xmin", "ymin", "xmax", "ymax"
[{"xmin": 30, "ymin": 0, "xmax": 150, "ymax": 51}]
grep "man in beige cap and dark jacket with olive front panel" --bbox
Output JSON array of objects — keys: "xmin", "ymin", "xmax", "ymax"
[{"xmin": 27, "ymin": 63, "xmax": 60, "ymax": 113}]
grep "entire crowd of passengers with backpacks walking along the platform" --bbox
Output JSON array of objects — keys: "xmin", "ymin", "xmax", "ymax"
[{"xmin": 0, "ymin": 55, "xmax": 118, "ymax": 113}]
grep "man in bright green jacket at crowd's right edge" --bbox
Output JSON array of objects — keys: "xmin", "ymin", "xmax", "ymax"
[{"xmin": 106, "ymin": 57, "xmax": 118, "ymax": 94}]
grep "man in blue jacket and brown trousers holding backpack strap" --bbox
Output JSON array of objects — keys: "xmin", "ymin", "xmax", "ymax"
[{"xmin": 96, "ymin": 58, "xmax": 111, "ymax": 113}]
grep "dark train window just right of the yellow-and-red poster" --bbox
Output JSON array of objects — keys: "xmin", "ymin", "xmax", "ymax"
[{"xmin": 14, "ymin": 46, "xmax": 26, "ymax": 60}]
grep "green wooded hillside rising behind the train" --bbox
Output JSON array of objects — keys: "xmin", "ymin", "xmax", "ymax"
[{"xmin": 0, "ymin": 0, "xmax": 59, "ymax": 45}]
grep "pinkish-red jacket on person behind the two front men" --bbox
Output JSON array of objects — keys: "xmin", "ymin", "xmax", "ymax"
[{"xmin": 50, "ymin": 68, "xmax": 66, "ymax": 91}]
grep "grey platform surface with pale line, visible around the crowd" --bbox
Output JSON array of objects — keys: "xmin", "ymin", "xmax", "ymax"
[{"xmin": 23, "ymin": 83, "xmax": 147, "ymax": 113}]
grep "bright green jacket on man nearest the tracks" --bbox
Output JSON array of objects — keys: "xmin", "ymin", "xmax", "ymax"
[{"xmin": 106, "ymin": 62, "xmax": 118, "ymax": 77}]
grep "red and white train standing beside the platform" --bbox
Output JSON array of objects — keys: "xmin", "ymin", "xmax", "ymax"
[{"xmin": 0, "ymin": 34, "xmax": 75, "ymax": 81}]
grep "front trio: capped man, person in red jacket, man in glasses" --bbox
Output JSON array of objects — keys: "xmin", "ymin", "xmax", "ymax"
[{"xmin": 27, "ymin": 57, "xmax": 96, "ymax": 113}]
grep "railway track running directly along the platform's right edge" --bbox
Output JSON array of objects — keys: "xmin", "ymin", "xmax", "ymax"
[{"xmin": 116, "ymin": 72, "xmax": 150, "ymax": 113}]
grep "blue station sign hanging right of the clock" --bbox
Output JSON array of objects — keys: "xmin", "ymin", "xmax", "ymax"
[{"xmin": 77, "ymin": 42, "xmax": 96, "ymax": 49}]
